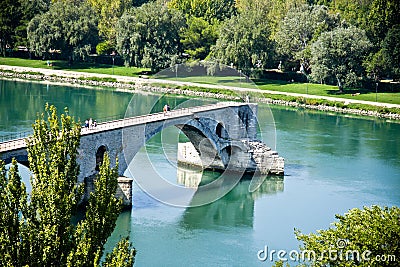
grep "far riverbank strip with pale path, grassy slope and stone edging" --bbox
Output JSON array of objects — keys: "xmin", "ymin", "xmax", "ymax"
[{"xmin": 0, "ymin": 65, "xmax": 400, "ymax": 120}]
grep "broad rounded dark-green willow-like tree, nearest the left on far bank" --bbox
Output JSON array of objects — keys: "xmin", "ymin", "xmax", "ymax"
[{"xmin": 27, "ymin": 0, "xmax": 98, "ymax": 59}]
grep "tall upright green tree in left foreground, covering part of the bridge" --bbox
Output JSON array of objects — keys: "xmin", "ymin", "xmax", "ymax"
[{"xmin": 0, "ymin": 106, "xmax": 135, "ymax": 266}]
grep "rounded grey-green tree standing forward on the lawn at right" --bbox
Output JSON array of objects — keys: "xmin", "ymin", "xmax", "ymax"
[{"xmin": 310, "ymin": 27, "xmax": 372, "ymax": 92}]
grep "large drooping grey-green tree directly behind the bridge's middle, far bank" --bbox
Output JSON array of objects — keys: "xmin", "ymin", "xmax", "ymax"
[{"xmin": 117, "ymin": 2, "xmax": 185, "ymax": 72}]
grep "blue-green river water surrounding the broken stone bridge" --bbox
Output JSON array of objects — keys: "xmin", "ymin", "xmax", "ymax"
[{"xmin": 0, "ymin": 80, "xmax": 400, "ymax": 266}]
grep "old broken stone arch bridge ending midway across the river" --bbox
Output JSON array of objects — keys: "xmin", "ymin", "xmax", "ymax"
[{"xmin": 0, "ymin": 102, "xmax": 284, "ymax": 205}]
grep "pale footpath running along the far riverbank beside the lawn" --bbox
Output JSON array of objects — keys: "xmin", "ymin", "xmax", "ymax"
[{"xmin": 0, "ymin": 65, "xmax": 400, "ymax": 108}]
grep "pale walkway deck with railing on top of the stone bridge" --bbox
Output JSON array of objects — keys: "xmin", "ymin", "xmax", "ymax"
[{"xmin": 0, "ymin": 102, "xmax": 246, "ymax": 153}]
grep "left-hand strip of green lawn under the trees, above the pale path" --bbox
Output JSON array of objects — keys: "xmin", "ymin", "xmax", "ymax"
[{"xmin": 0, "ymin": 57, "xmax": 149, "ymax": 76}]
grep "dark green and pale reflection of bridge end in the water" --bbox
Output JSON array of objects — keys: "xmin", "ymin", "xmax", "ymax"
[{"xmin": 177, "ymin": 167, "xmax": 284, "ymax": 229}]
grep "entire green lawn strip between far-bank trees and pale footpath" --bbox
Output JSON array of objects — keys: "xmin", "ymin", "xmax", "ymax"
[{"xmin": 0, "ymin": 57, "xmax": 400, "ymax": 104}]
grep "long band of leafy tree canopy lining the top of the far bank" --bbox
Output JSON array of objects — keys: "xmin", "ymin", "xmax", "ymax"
[{"xmin": 0, "ymin": 0, "xmax": 400, "ymax": 84}]
